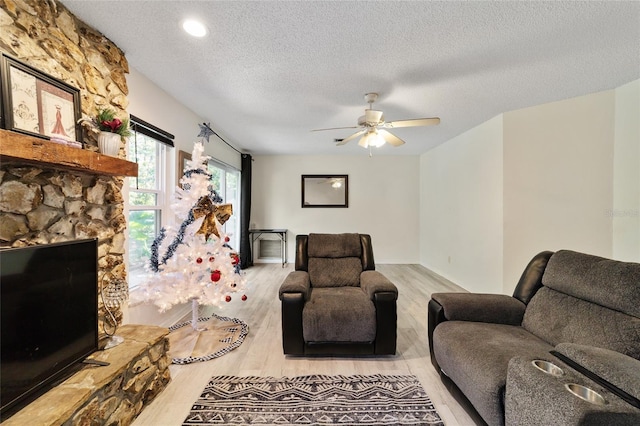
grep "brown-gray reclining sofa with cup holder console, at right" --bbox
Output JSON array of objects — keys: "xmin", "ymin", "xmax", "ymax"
[{"xmin": 428, "ymin": 250, "xmax": 640, "ymax": 425}]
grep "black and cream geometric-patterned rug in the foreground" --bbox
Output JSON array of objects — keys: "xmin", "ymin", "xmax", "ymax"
[{"xmin": 183, "ymin": 375, "xmax": 444, "ymax": 425}]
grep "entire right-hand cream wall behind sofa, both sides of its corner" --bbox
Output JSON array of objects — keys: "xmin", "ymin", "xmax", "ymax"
[{"xmin": 420, "ymin": 80, "xmax": 640, "ymax": 294}]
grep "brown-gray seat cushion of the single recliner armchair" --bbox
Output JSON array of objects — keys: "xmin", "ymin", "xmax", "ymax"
[{"xmin": 302, "ymin": 287, "xmax": 376, "ymax": 343}]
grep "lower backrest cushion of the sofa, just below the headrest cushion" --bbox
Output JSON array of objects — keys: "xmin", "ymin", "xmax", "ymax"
[{"xmin": 522, "ymin": 286, "xmax": 640, "ymax": 359}]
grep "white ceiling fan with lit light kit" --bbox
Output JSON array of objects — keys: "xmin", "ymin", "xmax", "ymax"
[{"xmin": 312, "ymin": 93, "xmax": 440, "ymax": 148}]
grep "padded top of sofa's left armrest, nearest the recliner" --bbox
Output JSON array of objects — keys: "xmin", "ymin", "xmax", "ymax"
[{"xmin": 431, "ymin": 293, "xmax": 526, "ymax": 325}]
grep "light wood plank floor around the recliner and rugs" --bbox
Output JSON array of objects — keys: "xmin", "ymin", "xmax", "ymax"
[{"xmin": 133, "ymin": 264, "xmax": 475, "ymax": 426}]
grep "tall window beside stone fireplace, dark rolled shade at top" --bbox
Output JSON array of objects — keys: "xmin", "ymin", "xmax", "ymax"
[{"xmin": 125, "ymin": 116, "xmax": 173, "ymax": 288}]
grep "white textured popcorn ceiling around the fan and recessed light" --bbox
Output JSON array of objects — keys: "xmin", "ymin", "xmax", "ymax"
[{"xmin": 62, "ymin": 0, "xmax": 640, "ymax": 155}]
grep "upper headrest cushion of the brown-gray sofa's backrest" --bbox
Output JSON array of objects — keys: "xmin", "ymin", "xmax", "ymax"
[{"xmin": 542, "ymin": 250, "xmax": 640, "ymax": 318}]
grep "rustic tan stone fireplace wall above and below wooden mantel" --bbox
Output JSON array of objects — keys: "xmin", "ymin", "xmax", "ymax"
[{"xmin": 0, "ymin": 0, "xmax": 129, "ymax": 322}]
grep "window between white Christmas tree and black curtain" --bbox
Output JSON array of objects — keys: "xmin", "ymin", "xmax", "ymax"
[{"xmin": 207, "ymin": 160, "xmax": 240, "ymax": 250}]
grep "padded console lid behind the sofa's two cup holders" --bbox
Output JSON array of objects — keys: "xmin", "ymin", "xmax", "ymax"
[{"xmin": 552, "ymin": 343, "xmax": 640, "ymax": 408}]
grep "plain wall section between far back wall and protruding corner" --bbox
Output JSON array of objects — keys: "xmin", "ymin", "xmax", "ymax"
[{"xmin": 420, "ymin": 116, "xmax": 503, "ymax": 293}]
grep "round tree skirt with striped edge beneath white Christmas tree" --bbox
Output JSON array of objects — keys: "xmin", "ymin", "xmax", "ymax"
[{"xmin": 167, "ymin": 314, "xmax": 249, "ymax": 364}]
